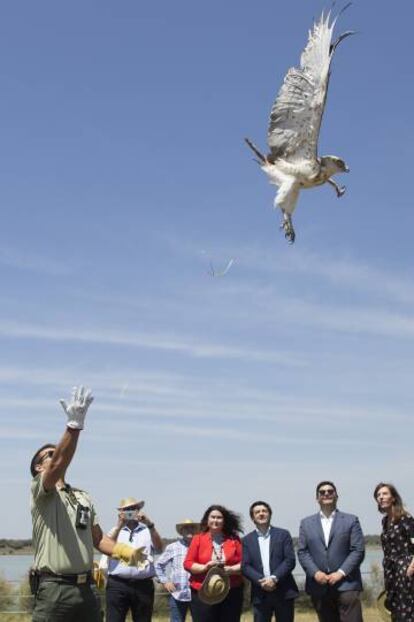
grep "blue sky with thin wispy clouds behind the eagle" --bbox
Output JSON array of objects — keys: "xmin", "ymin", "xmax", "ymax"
[{"xmin": 0, "ymin": 0, "xmax": 414, "ymax": 537}]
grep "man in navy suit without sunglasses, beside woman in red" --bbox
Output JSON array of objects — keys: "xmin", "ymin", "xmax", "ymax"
[{"xmin": 241, "ymin": 501, "xmax": 298, "ymax": 622}]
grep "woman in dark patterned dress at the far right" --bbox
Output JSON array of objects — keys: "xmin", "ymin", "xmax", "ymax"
[{"xmin": 374, "ymin": 482, "xmax": 414, "ymax": 622}]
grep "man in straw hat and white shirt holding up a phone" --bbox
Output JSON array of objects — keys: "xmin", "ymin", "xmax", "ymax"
[{"xmin": 106, "ymin": 497, "xmax": 163, "ymax": 622}]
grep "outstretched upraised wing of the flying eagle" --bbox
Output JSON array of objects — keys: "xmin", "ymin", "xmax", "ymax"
[{"xmin": 268, "ymin": 12, "xmax": 353, "ymax": 162}]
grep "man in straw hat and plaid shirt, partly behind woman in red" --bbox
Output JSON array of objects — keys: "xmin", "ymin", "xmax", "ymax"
[{"xmin": 155, "ymin": 518, "xmax": 200, "ymax": 622}]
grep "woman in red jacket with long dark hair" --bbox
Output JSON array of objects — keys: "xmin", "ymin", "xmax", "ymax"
[{"xmin": 184, "ymin": 505, "xmax": 243, "ymax": 622}]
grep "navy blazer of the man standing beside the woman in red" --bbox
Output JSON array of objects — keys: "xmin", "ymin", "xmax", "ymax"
[{"xmin": 241, "ymin": 527, "xmax": 298, "ymax": 603}]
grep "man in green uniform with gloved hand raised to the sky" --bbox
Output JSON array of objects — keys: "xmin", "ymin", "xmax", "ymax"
[{"xmin": 30, "ymin": 387, "xmax": 147, "ymax": 622}]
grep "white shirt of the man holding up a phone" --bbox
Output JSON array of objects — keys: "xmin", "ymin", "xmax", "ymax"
[{"xmin": 108, "ymin": 523, "xmax": 155, "ymax": 579}]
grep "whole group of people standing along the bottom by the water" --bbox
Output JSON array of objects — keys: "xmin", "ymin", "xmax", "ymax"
[{"xmin": 30, "ymin": 387, "xmax": 414, "ymax": 622}]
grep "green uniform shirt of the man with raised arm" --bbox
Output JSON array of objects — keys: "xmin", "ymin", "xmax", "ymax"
[{"xmin": 31, "ymin": 473, "xmax": 98, "ymax": 574}]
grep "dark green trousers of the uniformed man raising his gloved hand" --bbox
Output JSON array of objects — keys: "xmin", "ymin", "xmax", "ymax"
[{"xmin": 32, "ymin": 581, "xmax": 102, "ymax": 622}]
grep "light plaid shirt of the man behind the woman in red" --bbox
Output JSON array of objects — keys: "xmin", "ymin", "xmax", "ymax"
[{"xmin": 155, "ymin": 538, "xmax": 191, "ymax": 602}]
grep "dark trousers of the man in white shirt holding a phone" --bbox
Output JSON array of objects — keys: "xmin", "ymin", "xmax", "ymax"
[{"xmin": 106, "ymin": 575, "xmax": 154, "ymax": 622}]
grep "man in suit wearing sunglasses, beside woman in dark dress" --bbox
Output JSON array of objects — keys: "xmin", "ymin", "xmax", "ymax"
[{"xmin": 298, "ymin": 481, "xmax": 365, "ymax": 622}]
